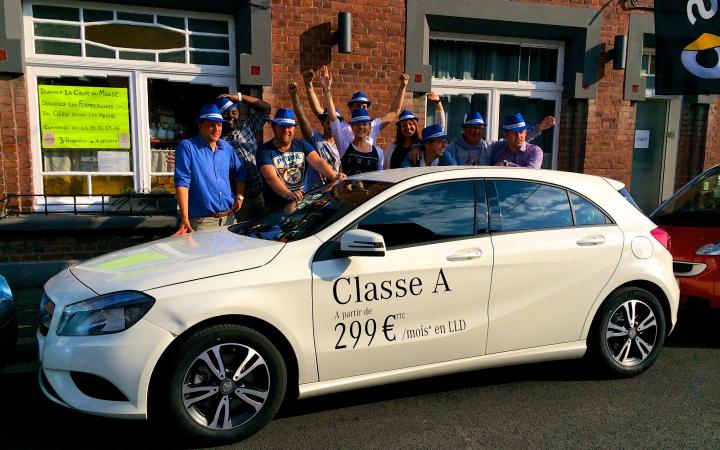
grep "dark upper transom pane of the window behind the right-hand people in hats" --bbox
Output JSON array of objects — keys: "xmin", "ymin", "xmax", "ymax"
[{"xmin": 430, "ymin": 39, "xmax": 558, "ymax": 83}]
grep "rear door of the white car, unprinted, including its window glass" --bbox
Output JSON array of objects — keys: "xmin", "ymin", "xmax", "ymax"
[{"xmin": 487, "ymin": 180, "xmax": 623, "ymax": 354}]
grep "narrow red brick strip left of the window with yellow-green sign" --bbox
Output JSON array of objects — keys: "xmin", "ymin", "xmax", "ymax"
[{"xmin": 0, "ymin": 76, "xmax": 33, "ymax": 200}]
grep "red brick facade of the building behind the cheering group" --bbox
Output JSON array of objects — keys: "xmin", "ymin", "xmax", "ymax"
[{"xmin": 0, "ymin": 0, "xmax": 720, "ymax": 229}]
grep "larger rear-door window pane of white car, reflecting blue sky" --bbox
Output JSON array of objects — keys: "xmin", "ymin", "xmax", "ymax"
[{"xmin": 491, "ymin": 180, "xmax": 573, "ymax": 231}]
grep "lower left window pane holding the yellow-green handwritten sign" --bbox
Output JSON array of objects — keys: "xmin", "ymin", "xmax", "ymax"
[{"xmin": 37, "ymin": 77, "xmax": 134, "ymax": 195}]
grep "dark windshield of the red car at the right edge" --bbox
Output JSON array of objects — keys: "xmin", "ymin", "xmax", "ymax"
[{"xmin": 652, "ymin": 170, "xmax": 720, "ymax": 227}]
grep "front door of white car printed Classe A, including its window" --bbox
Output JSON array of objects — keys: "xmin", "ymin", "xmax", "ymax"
[{"xmin": 312, "ymin": 180, "xmax": 493, "ymax": 380}]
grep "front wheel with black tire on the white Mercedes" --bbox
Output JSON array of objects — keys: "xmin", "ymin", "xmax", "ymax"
[{"xmin": 163, "ymin": 324, "xmax": 287, "ymax": 445}]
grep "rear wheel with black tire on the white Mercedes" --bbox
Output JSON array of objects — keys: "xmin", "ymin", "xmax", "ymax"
[{"xmin": 589, "ymin": 287, "xmax": 665, "ymax": 377}]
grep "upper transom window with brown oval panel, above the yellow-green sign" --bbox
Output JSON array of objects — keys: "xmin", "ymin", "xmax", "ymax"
[{"xmin": 31, "ymin": 4, "xmax": 232, "ymax": 67}]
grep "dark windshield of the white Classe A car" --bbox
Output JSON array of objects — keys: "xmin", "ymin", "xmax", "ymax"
[{"xmin": 228, "ymin": 180, "xmax": 392, "ymax": 242}]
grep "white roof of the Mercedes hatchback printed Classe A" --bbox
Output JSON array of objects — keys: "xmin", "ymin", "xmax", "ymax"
[{"xmin": 349, "ymin": 166, "xmax": 625, "ymax": 190}]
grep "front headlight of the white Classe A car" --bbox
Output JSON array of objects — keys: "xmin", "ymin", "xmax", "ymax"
[{"xmin": 57, "ymin": 291, "xmax": 155, "ymax": 336}]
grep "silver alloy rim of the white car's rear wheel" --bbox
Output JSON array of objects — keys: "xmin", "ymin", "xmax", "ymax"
[{"xmin": 605, "ymin": 300, "xmax": 658, "ymax": 367}]
